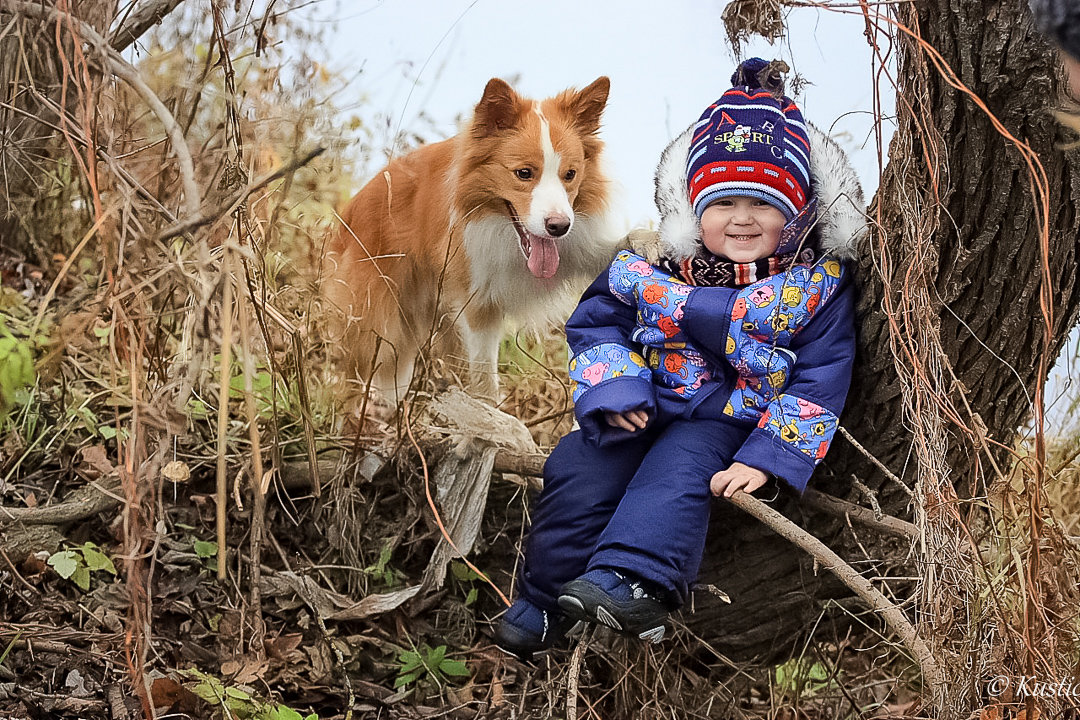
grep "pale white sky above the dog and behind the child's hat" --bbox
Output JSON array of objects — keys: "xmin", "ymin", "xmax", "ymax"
[{"xmin": 327, "ymin": 0, "xmax": 892, "ymax": 225}]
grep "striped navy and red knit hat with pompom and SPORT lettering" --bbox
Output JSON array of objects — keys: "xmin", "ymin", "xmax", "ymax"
[{"xmin": 686, "ymin": 57, "xmax": 810, "ymax": 221}]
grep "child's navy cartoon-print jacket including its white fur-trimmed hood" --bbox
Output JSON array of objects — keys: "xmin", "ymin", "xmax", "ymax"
[{"xmin": 566, "ymin": 123, "xmax": 866, "ymax": 492}]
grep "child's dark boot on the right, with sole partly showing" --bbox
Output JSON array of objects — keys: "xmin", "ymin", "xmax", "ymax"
[{"xmin": 558, "ymin": 568, "xmax": 667, "ymax": 642}]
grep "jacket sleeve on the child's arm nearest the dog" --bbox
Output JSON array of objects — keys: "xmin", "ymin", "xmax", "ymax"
[{"xmin": 566, "ymin": 264, "xmax": 657, "ymax": 445}]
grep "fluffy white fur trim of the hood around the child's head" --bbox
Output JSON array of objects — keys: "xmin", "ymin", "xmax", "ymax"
[{"xmin": 656, "ymin": 122, "xmax": 866, "ymax": 260}]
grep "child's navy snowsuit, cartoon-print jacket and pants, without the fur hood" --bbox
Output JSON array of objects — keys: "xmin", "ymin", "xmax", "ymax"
[{"xmin": 509, "ymin": 119, "xmax": 854, "ymax": 609}]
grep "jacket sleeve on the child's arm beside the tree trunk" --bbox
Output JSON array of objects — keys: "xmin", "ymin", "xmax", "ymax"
[{"xmin": 734, "ymin": 273, "xmax": 855, "ymax": 494}]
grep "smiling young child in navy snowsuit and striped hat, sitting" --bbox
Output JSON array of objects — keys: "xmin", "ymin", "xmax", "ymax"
[{"xmin": 496, "ymin": 58, "xmax": 864, "ymax": 660}]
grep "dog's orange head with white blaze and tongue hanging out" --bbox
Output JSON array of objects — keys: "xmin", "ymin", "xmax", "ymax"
[{"xmin": 455, "ymin": 77, "xmax": 610, "ymax": 279}]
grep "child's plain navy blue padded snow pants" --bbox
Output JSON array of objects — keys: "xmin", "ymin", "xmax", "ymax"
[{"xmin": 518, "ymin": 419, "xmax": 752, "ymax": 610}]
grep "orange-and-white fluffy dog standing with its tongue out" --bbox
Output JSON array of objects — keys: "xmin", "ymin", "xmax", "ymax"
[{"xmin": 323, "ymin": 77, "xmax": 618, "ymax": 402}]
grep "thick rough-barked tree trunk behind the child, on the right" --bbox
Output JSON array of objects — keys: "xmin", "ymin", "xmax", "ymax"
[{"xmin": 688, "ymin": 0, "xmax": 1080, "ymax": 661}]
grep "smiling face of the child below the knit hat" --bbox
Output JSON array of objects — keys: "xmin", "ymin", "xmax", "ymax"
[{"xmin": 701, "ymin": 195, "xmax": 787, "ymax": 262}]
